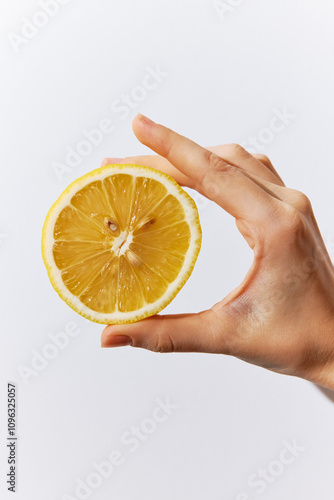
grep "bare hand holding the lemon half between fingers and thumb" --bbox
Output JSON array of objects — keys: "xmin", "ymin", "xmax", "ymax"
[{"xmin": 102, "ymin": 115, "xmax": 334, "ymax": 389}]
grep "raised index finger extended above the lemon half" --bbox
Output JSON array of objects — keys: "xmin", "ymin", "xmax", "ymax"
[{"xmin": 133, "ymin": 115, "xmax": 279, "ymax": 221}]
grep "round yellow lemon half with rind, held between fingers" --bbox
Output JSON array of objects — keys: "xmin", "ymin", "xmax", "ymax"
[{"xmin": 42, "ymin": 164, "xmax": 202, "ymax": 324}]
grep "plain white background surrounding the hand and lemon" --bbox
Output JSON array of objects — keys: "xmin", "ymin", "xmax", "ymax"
[{"xmin": 0, "ymin": 0, "xmax": 334, "ymax": 500}]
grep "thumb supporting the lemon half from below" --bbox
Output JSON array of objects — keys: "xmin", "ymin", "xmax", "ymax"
[{"xmin": 101, "ymin": 309, "xmax": 223, "ymax": 352}]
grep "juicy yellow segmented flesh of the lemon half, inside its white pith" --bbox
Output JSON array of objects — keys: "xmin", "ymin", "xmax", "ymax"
[{"xmin": 52, "ymin": 174, "xmax": 191, "ymax": 314}]
